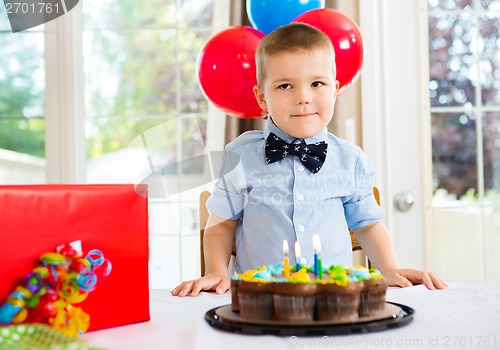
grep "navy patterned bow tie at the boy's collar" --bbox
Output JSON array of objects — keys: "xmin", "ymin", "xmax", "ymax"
[{"xmin": 266, "ymin": 133, "xmax": 328, "ymax": 174}]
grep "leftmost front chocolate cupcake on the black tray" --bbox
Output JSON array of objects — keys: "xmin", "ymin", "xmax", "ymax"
[{"xmin": 237, "ymin": 267, "xmax": 273, "ymax": 320}]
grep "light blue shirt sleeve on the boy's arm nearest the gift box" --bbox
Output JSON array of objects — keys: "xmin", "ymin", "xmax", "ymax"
[{"xmin": 206, "ymin": 148, "xmax": 245, "ymax": 220}]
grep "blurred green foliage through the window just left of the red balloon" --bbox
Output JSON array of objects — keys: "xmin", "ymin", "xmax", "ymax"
[{"xmin": 84, "ymin": 0, "xmax": 211, "ymax": 158}]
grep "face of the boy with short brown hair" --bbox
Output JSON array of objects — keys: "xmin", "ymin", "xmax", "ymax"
[{"xmin": 254, "ymin": 48, "xmax": 338, "ymax": 139}]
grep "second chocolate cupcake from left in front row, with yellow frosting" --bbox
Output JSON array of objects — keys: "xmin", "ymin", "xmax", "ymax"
[{"xmin": 273, "ymin": 269, "xmax": 317, "ymax": 322}]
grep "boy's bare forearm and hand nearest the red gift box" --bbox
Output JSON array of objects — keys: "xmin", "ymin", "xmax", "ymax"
[{"xmin": 172, "ymin": 214, "xmax": 238, "ymax": 297}]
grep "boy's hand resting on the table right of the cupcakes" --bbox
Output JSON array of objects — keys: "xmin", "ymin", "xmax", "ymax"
[{"xmin": 383, "ymin": 269, "xmax": 448, "ymax": 289}]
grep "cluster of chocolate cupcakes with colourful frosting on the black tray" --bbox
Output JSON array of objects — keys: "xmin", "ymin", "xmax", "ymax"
[{"xmin": 231, "ymin": 263, "xmax": 387, "ymax": 322}]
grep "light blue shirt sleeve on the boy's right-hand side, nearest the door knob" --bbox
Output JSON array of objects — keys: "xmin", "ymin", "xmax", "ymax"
[{"xmin": 344, "ymin": 151, "xmax": 384, "ymax": 229}]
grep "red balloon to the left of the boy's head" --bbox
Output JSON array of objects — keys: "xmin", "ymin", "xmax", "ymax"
[{"xmin": 197, "ymin": 26, "xmax": 265, "ymax": 118}]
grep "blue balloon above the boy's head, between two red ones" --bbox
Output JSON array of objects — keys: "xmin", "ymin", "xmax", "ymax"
[{"xmin": 247, "ymin": 0, "xmax": 325, "ymax": 34}]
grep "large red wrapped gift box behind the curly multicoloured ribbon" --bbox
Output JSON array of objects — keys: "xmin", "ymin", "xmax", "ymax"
[{"xmin": 0, "ymin": 185, "xmax": 150, "ymax": 331}]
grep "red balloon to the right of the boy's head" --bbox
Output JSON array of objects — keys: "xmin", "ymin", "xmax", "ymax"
[{"xmin": 293, "ymin": 8, "xmax": 363, "ymax": 94}]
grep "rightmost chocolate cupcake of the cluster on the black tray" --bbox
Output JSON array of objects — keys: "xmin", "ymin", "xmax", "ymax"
[{"xmin": 349, "ymin": 266, "xmax": 387, "ymax": 317}]
